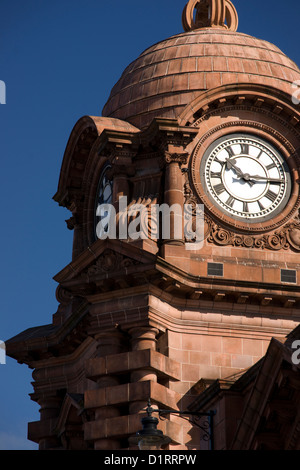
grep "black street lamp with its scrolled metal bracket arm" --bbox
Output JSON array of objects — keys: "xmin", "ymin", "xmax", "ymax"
[{"xmin": 129, "ymin": 400, "xmax": 216, "ymax": 450}]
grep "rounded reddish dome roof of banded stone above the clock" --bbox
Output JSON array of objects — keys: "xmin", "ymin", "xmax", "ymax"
[{"xmin": 103, "ymin": 1, "xmax": 300, "ymax": 129}]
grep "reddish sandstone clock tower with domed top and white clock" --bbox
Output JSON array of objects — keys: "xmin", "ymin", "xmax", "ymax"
[{"xmin": 6, "ymin": 0, "xmax": 300, "ymax": 450}]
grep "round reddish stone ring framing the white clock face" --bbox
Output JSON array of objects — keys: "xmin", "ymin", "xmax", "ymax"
[{"xmin": 190, "ymin": 127, "xmax": 299, "ymax": 232}]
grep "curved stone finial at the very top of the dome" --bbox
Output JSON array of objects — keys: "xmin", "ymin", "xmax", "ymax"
[{"xmin": 182, "ymin": 0, "xmax": 238, "ymax": 31}]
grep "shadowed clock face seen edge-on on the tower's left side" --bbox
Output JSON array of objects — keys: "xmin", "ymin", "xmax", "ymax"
[{"xmin": 95, "ymin": 166, "xmax": 112, "ymax": 238}]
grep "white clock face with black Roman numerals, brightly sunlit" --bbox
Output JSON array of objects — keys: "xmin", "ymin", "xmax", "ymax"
[{"xmin": 200, "ymin": 134, "xmax": 291, "ymax": 223}]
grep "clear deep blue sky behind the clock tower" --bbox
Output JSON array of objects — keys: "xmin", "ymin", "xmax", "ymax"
[{"xmin": 0, "ymin": 0, "xmax": 300, "ymax": 450}]
